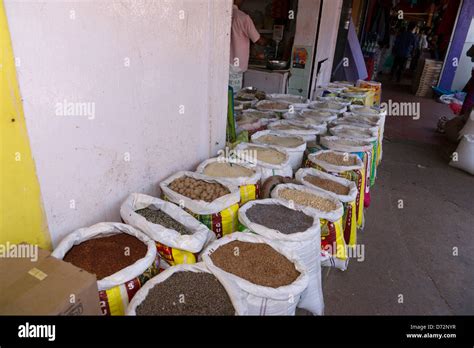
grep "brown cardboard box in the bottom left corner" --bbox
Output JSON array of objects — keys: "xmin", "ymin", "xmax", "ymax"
[{"xmin": 0, "ymin": 248, "xmax": 101, "ymax": 315}]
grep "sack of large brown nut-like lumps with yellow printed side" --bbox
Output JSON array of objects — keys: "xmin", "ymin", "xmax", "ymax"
[{"xmin": 160, "ymin": 172, "xmax": 240, "ymax": 238}]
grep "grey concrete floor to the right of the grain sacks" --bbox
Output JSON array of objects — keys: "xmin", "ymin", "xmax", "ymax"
[{"xmin": 323, "ymin": 77, "xmax": 474, "ymax": 315}]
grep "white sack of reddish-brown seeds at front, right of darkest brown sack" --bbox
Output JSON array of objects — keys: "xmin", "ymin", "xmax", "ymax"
[{"xmin": 202, "ymin": 232, "xmax": 308, "ymax": 315}]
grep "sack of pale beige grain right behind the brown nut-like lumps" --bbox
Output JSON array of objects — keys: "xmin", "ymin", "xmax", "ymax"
[{"xmin": 196, "ymin": 157, "xmax": 262, "ymax": 205}]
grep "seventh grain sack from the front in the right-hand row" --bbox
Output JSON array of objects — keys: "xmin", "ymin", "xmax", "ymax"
[{"xmin": 329, "ymin": 124, "xmax": 379, "ymax": 185}]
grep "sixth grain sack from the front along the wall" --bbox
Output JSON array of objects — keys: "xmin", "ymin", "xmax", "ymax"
[{"xmin": 252, "ymin": 130, "xmax": 306, "ymax": 172}]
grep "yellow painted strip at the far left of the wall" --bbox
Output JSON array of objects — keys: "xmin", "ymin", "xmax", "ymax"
[{"xmin": 0, "ymin": 0, "xmax": 51, "ymax": 249}]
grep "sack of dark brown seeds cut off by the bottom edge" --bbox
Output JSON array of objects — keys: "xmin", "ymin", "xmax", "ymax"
[{"xmin": 126, "ymin": 262, "xmax": 235, "ymax": 316}]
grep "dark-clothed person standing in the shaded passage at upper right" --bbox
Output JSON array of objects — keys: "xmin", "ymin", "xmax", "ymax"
[{"xmin": 392, "ymin": 22, "xmax": 416, "ymax": 83}]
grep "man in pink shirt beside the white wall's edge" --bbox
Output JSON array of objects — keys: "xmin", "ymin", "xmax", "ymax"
[{"xmin": 229, "ymin": 0, "xmax": 268, "ymax": 92}]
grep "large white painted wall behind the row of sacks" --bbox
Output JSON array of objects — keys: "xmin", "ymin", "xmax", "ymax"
[{"xmin": 5, "ymin": 0, "xmax": 232, "ymax": 245}]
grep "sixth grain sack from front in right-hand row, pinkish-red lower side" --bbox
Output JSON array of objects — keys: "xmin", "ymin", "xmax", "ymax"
[{"xmin": 321, "ymin": 136, "xmax": 374, "ymax": 207}]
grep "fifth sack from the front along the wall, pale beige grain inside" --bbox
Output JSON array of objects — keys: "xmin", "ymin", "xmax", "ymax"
[{"xmin": 235, "ymin": 143, "xmax": 293, "ymax": 184}]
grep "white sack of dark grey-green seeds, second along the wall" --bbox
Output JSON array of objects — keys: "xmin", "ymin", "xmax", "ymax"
[{"xmin": 120, "ymin": 193, "xmax": 216, "ymax": 266}]
